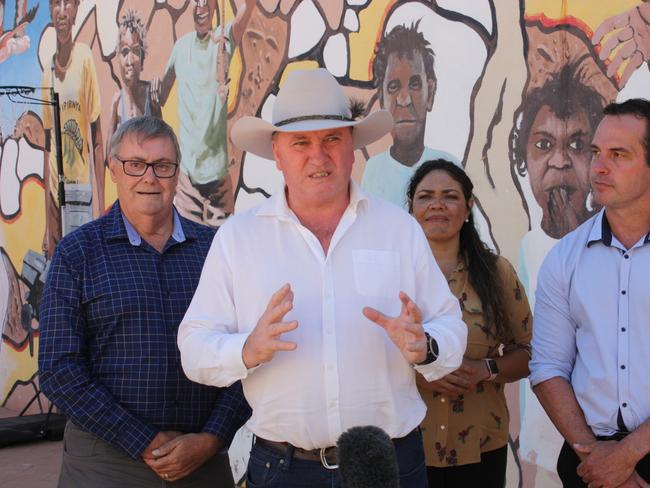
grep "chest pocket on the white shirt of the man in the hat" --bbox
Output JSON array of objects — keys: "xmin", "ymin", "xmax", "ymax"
[{"xmin": 352, "ymin": 249, "xmax": 400, "ymax": 298}]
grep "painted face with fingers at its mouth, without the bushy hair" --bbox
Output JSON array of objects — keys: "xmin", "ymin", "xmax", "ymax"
[{"xmin": 526, "ymin": 105, "xmax": 592, "ymax": 239}]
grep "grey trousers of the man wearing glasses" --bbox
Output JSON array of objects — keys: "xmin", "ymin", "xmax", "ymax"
[{"xmin": 59, "ymin": 422, "xmax": 235, "ymax": 488}]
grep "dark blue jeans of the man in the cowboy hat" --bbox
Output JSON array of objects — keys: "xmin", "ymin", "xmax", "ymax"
[{"xmin": 246, "ymin": 430, "xmax": 427, "ymax": 488}]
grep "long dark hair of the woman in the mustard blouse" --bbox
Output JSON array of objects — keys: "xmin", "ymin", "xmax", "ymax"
[{"xmin": 406, "ymin": 159, "xmax": 507, "ymax": 341}]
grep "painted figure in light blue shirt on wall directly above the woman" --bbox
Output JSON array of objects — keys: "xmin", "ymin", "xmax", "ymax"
[{"xmin": 361, "ymin": 21, "xmax": 456, "ymax": 208}]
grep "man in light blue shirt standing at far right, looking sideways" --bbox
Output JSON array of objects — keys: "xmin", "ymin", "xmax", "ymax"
[{"xmin": 530, "ymin": 99, "xmax": 650, "ymax": 487}]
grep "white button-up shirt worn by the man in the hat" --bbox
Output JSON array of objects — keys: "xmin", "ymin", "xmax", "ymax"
[{"xmin": 178, "ymin": 183, "xmax": 467, "ymax": 449}]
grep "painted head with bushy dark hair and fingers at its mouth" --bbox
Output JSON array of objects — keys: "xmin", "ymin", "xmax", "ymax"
[{"xmin": 514, "ymin": 65, "xmax": 605, "ymax": 239}]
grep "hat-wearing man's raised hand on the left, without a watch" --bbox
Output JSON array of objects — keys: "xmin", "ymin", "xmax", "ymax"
[{"xmin": 242, "ymin": 284, "xmax": 298, "ymax": 369}]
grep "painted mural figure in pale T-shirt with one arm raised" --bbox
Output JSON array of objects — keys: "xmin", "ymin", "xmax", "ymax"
[{"xmin": 152, "ymin": 0, "xmax": 255, "ymax": 227}]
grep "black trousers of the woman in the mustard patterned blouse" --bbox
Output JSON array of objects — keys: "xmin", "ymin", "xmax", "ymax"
[{"xmin": 427, "ymin": 445, "xmax": 508, "ymax": 488}]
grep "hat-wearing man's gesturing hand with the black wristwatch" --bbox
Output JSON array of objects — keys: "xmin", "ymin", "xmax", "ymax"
[{"xmin": 363, "ymin": 291, "xmax": 427, "ymax": 364}]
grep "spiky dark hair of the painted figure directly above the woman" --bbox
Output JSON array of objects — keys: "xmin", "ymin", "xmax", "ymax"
[{"xmin": 372, "ymin": 20, "xmax": 436, "ymax": 89}]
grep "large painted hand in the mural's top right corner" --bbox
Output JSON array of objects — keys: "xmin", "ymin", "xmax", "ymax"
[{"xmin": 591, "ymin": 2, "xmax": 650, "ymax": 88}]
